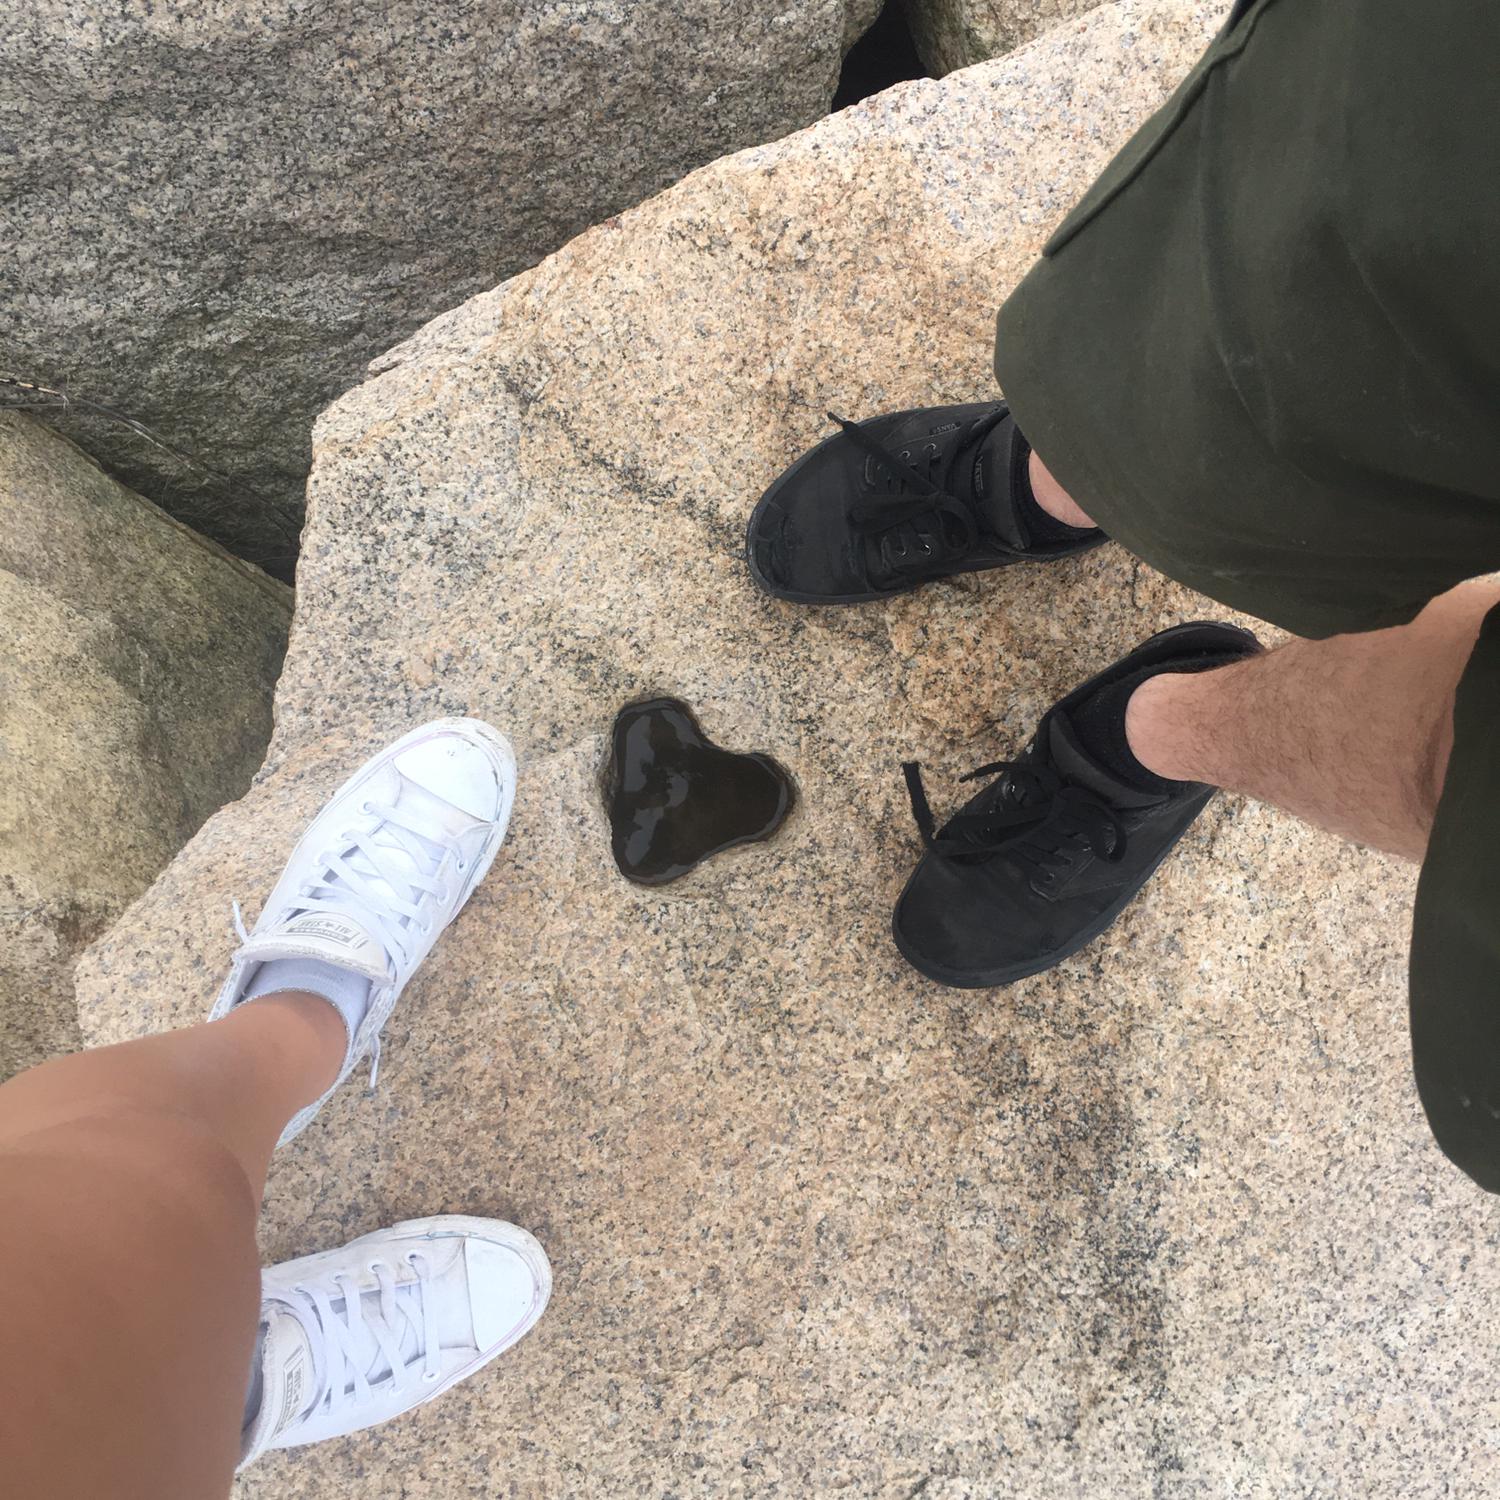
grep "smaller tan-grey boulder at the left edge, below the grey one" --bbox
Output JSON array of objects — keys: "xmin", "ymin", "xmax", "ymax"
[{"xmin": 0, "ymin": 413, "xmax": 291, "ymax": 1079}]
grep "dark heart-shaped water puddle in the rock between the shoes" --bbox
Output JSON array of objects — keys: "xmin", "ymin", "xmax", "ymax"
[{"xmin": 605, "ymin": 698, "xmax": 797, "ymax": 885}]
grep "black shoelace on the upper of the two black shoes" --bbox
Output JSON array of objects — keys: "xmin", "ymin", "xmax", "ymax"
[{"xmin": 828, "ymin": 410, "xmax": 1010, "ymax": 588}]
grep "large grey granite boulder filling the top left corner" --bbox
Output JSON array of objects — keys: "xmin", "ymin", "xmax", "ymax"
[{"xmin": 0, "ymin": 0, "xmax": 881, "ymax": 570}]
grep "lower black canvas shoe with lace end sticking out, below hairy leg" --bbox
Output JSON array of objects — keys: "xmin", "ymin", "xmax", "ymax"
[{"xmin": 891, "ymin": 624, "xmax": 1260, "ymax": 989}]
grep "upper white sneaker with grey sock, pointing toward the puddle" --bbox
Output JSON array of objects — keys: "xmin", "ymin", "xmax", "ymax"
[{"xmin": 209, "ymin": 719, "xmax": 516, "ymax": 1145}]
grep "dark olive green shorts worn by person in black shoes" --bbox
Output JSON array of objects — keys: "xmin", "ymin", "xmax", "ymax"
[{"xmin": 995, "ymin": 0, "xmax": 1500, "ymax": 1191}]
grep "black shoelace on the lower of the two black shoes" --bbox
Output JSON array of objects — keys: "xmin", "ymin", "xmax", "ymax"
[{"xmin": 902, "ymin": 761, "xmax": 1125, "ymax": 884}]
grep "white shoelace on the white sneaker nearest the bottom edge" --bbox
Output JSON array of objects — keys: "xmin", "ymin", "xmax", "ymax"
[{"xmin": 288, "ymin": 1254, "xmax": 443, "ymax": 1413}]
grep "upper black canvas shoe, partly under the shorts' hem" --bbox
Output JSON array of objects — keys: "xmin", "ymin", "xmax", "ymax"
[{"xmin": 746, "ymin": 402, "xmax": 1104, "ymax": 605}]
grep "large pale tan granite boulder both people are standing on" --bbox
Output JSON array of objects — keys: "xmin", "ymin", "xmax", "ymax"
[{"xmin": 83, "ymin": 0, "xmax": 1500, "ymax": 1500}]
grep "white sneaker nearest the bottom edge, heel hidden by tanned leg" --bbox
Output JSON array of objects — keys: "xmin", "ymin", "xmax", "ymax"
[{"xmin": 239, "ymin": 1214, "xmax": 552, "ymax": 1469}]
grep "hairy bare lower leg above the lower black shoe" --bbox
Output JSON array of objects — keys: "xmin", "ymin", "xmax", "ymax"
[{"xmin": 1125, "ymin": 578, "xmax": 1500, "ymax": 860}]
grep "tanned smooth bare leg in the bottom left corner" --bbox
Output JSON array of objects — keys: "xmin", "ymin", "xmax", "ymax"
[{"xmin": 0, "ymin": 995, "xmax": 348, "ymax": 1500}]
